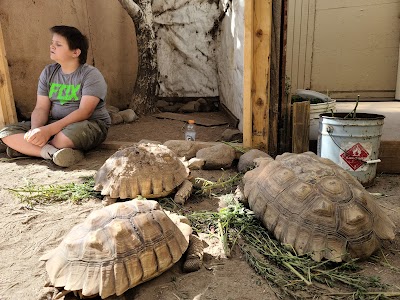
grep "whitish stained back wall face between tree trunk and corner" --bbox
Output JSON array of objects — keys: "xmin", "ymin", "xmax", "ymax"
[{"xmin": 152, "ymin": 0, "xmax": 220, "ymax": 97}]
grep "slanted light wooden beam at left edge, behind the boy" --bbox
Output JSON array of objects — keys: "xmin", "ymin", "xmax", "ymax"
[{"xmin": 0, "ymin": 20, "xmax": 18, "ymax": 128}]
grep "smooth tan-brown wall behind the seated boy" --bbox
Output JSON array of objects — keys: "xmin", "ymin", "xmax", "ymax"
[{"xmin": 0, "ymin": 0, "xmax": 137, "ymax": 113}]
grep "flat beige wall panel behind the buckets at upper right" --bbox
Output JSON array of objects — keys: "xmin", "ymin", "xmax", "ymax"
[{"xmin": 287, "ymin": 0, "xmax": 400, "ymax": 99}]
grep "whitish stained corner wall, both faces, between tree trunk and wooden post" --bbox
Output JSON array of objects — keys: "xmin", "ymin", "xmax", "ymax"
[{"xmin": 152, "ymin": 0, "xmax": 244, "ymax": 129}]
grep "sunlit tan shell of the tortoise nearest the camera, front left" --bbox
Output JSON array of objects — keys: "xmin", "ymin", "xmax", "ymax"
[{"xmin": 40, "ymin": 200, "xmax": 192, "ymax": 299}]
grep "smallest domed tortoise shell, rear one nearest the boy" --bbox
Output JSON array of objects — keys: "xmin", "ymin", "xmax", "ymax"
[{"xmin": 94, "ymin": 143, "xmax": 189, "ymax": 199}]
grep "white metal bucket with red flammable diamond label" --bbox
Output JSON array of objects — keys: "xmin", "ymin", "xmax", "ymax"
[{"xmin": 317, "ymin": 113, "xmax": 385, "ymax": 187}]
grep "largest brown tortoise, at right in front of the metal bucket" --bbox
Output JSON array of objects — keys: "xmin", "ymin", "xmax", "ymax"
[{"xmin": 243, "ymin": 152, "xmax": 395, "ymax": 262}]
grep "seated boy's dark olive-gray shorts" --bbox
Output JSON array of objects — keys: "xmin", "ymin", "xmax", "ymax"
[{"xmin": 0, "ymin": 120, "xmax": 108, "ymax": 151}]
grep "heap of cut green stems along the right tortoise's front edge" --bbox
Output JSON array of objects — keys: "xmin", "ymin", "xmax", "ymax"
[{"xmin": 189, "ymin": 204, "xmax": 387, "ymax": 299}]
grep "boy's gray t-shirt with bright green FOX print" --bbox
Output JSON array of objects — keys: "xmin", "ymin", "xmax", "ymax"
[{"xmin": 37, "ymin": 63, "xmax": 111, "ymax": 125}]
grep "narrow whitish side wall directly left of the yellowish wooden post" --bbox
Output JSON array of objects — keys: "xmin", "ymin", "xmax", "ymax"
[{"xmin": 217, "ymin": 0, "xmax": 244, "ymax": 130}]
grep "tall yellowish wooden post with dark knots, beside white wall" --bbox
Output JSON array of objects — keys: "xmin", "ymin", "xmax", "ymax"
[{"xmin": 243, "ymin": 0, "xmax": 272, "ymax": 152}]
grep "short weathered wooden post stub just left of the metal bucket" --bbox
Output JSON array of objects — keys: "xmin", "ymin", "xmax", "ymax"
[{"xmin": 292, "ymin": 101, "xmax": 310, "ymax": 153}]
